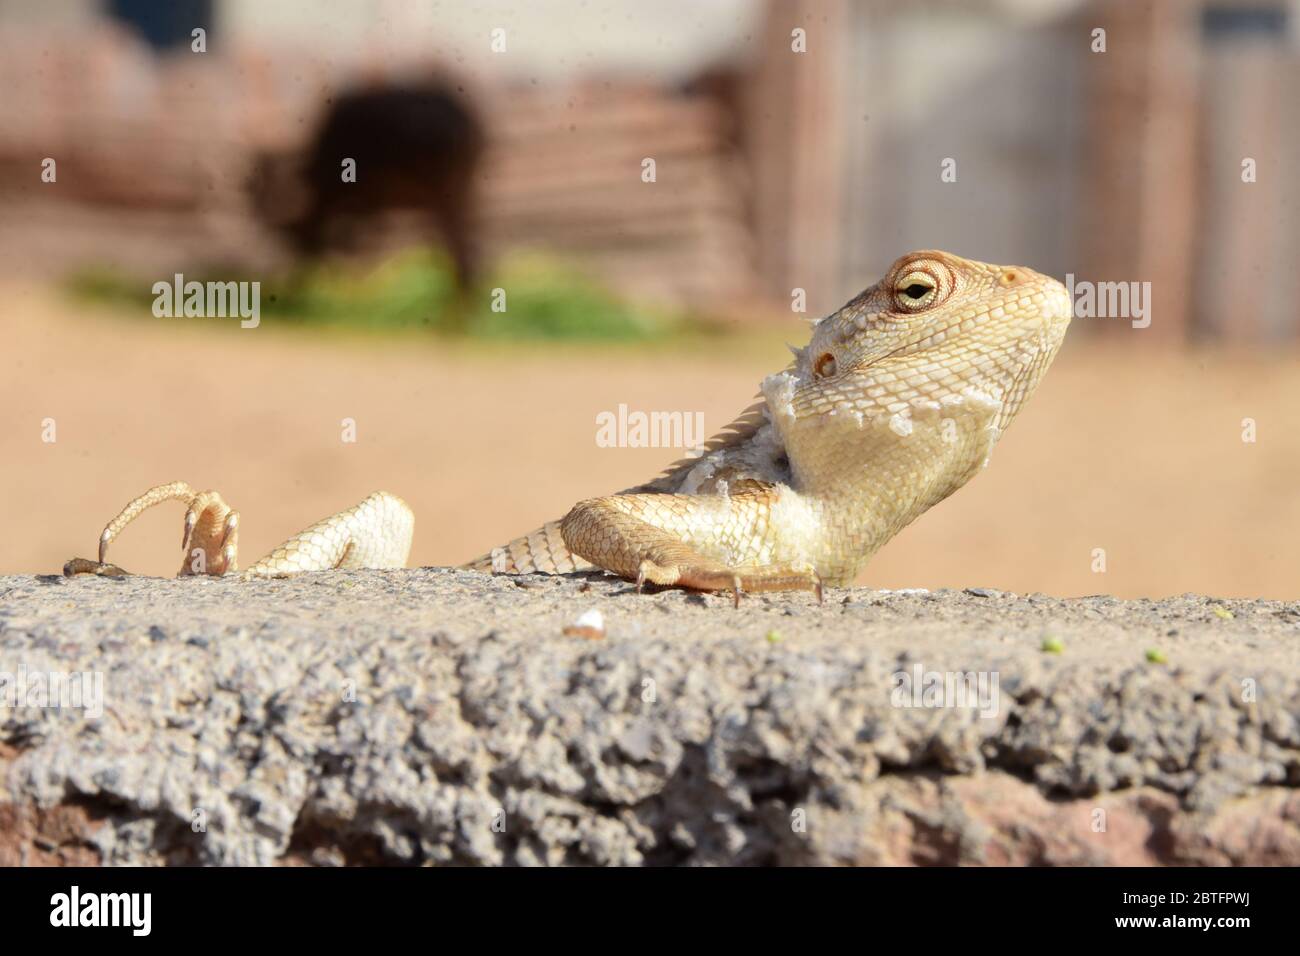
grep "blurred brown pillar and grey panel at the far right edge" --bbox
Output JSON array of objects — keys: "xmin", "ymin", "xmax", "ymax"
[{"xmin": 1076, "ymin": 0, "xmax": 1300, "ymax": 342}]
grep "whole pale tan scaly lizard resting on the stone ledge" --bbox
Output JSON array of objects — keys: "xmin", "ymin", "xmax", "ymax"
[{"xmin": 65, "ymin": 250, "xmax": 1073, "ymax": 604}]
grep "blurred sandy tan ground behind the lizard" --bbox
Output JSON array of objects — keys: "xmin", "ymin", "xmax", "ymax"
[{"xmin": 0, "ymin": 280, "xmax": 1300, "ymax": 598}]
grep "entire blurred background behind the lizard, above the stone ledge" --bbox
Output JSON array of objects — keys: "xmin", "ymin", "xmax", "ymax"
[{"xmin": 0, "ymin": 0, "xmax": 1300, "ymax": 597}]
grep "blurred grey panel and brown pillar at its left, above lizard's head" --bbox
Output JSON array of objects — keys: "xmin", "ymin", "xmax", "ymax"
[{"xmin": 753, "ymin": 0, "xmax": 1087, "ymax": 311}]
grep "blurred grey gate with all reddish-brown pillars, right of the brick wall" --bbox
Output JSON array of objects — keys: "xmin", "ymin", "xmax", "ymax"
[{"xmin": 754, "ymin": 0, "xmax": 1300, "ymax": 342}]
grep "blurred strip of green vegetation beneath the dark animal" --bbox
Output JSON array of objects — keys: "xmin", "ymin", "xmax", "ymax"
[{"xmin": 69, "ymin": 250, "xmax": 689, "ymax": 342}]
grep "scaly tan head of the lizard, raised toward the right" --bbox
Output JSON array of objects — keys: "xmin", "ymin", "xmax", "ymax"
[{"xmin": 774, "ymin": 251, "xmax": 1071, "ymax": 429}]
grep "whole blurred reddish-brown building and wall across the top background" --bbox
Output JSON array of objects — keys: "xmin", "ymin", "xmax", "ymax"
[{"xmin": 0, "ymin": 0, "xmax": 1300, "ymax": 342}]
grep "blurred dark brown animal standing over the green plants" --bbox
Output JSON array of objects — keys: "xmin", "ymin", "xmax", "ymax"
[{"xmin": 251, "ymin": 86, "xmax": 484, "ymax": 289}]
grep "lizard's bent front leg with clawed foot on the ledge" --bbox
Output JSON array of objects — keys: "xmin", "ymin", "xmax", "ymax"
[{"xmin": 560, "ymin": 483, "xmax": 822, "ymax": 605}]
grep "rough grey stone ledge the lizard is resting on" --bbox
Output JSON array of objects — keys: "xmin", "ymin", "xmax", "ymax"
[{"xmin": 0, "ymin": 568, "xmax": 1300, "ymax": 865}]
